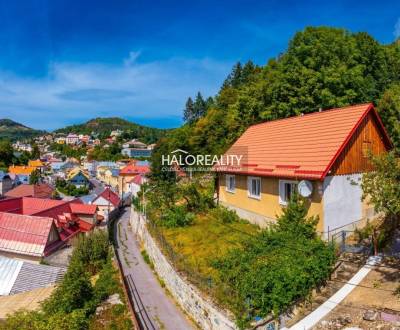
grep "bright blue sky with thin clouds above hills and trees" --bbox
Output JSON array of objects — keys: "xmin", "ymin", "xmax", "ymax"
[{"xmin": 0, "ymin": 0, "xmax": 400, "ymax": 130}]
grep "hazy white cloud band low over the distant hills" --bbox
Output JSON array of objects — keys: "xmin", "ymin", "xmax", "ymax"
[{"xmin": 0, "ymin": 53, "xmax": 232, "ymax": 129}]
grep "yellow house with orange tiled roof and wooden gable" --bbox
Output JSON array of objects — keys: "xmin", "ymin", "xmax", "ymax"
[{"xmin": 215, "ymin": 104, "xmax": 392, "ymax": 237}]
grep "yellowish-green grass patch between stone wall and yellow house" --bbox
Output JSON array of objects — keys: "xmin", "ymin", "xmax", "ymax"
[{"xmin": 158, "ymin": 213, "xmax": 259, "ymax": 278}]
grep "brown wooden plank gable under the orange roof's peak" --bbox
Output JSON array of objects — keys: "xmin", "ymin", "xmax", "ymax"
[{"xmin": 328, "ymin": 112, "xmax": 390, "ymax": 175}]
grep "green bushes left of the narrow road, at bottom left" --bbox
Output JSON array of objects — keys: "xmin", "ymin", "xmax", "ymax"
[{"xmin": 0, "ymin": 231, "xmax": 122, "ymax": 330}]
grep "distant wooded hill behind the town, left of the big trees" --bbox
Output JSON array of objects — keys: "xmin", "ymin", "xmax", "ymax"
[{"xmin": 55, "ymin": 117, "xmax": 168, "ymax": 143}]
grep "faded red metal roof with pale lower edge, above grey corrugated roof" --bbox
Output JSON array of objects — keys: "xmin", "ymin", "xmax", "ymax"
[{"xmin": 0, "ymin": 212, "xmax": 53, "ymax": 256}]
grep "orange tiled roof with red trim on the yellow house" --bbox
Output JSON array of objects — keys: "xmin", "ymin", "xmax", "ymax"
[{"xmin": 216, "ymin": 104, "xmax": 391, "ymax": 179}]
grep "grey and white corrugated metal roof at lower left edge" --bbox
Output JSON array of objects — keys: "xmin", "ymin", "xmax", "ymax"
[{"xmin": 0, "ymin": 256, "xmax": 66, "ymax": 296}]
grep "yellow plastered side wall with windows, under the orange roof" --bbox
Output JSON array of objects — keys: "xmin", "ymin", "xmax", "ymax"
[{"xmin": 219, "ymin": 174, "xmax": 323, "ymax": 231}]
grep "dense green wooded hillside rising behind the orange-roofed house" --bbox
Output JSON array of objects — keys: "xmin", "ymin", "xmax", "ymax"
[{"xmin": 153, "ymin": 27, "xmax": 400, "ymax": 170}]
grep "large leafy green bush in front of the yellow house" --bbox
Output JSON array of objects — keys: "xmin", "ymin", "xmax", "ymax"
[{"xmin": 213, "ymin": 197, "xmax": 335, "ymax": 328}]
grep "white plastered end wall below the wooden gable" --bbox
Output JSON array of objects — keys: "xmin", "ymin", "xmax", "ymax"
[{"xmin": 323, "ymin": 174, "xmax": 362, "ymax": 232}]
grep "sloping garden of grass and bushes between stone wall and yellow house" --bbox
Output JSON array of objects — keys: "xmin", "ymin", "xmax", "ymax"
[{"xmin": 142, "ymin": 177, "xmax": 335, "ymax": 328}]
